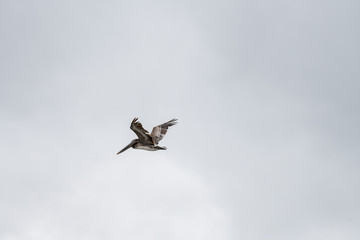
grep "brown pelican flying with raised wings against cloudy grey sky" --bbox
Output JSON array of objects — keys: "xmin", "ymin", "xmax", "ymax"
[{"xmin": 117, "ymin": 118, "xmax": 177, "ymax": 154}]
